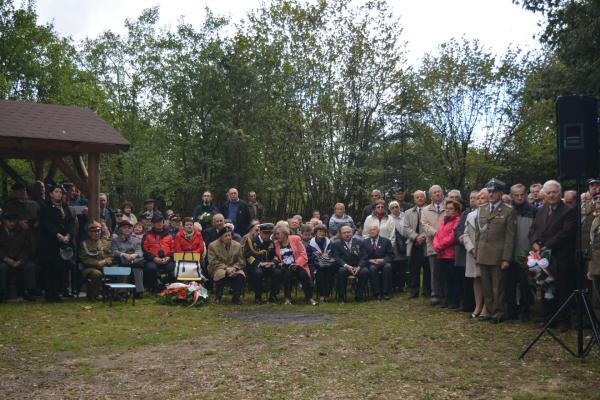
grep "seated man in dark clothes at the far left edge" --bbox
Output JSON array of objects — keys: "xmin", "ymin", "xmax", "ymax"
[{"xmin": 0, "ymin": 212, "xmax": 35, "ymax": 302}]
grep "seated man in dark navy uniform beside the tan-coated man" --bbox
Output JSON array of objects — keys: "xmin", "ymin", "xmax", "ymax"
[{"xmin": 244, "ymin": 224, "xmax": 282, "ymax": 304}]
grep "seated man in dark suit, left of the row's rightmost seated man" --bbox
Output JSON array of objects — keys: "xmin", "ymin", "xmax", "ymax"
[{"xmin": 333, "ymin": 225, "xmax": 369, "ymax": 301}]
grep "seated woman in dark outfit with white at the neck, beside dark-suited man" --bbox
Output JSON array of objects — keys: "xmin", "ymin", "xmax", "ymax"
[{"xmin": 308, "ymin": 224, "xmax": 337, "ymax": 302}]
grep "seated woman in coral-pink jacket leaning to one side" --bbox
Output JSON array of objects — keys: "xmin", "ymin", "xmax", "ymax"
[{"xmin": 273, "ymin": 223, "xmax": 319, "ymax": 305}]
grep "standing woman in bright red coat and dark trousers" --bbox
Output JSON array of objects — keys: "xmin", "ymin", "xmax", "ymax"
[{"xmin": 433, "ymin": 200, "xmax": 464, "ymax": 311}]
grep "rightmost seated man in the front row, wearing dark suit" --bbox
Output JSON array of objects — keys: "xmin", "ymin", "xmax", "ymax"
[{"xmin": 360, "ymin": 225, "xmax": 394, "ymax": 300}]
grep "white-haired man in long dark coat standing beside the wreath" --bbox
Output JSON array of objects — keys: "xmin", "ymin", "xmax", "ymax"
[{"xmin": 529, "ymin": 180, "xmax": 577, "ymax": 332}]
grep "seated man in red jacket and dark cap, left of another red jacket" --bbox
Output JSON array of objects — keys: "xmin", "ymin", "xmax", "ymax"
[{"xmin": 142, "ymin": 216, "xmax": 175, "ymax": 291}]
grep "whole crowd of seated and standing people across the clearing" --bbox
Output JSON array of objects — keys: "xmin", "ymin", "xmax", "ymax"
[{"xmin": 0, "ymin": 179, "xmax": 600, "ymax": 330}]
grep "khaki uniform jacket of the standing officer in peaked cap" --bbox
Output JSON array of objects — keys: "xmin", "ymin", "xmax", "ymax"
[{"xmin": 475, "ymin": 202, "xmax": 517, "ymax": 266}]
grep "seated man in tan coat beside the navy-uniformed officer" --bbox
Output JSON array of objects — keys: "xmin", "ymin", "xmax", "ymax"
[{"xmin": 208, "ymin": 227, "xmax": 246, "ymax": 304}]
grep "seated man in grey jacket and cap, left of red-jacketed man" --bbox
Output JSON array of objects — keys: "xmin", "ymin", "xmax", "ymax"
[{"xmin": 112, "ymin": 219, "xmax": 145, "ymax": 299}]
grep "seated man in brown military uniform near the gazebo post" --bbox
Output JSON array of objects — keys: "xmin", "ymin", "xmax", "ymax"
[{"xmin": 79, "ymin": 222, "xmax": 113, "ymax": 300}]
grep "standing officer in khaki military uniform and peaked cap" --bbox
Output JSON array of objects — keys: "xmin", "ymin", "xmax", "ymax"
[{"xmin": 475, "ymin": 179, "xmax": 516, "ymax": 324}]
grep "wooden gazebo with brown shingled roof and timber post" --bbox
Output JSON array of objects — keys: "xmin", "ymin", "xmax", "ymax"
[{"xmin": 0, "ymin": 100, "xmax": 129, "ymax": 219}]
